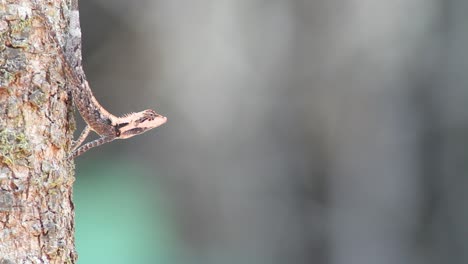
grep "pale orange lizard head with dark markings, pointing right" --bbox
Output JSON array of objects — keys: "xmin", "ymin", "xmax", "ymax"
[{"xmin": 115, "ymin": 109, "xmax": 167, "ymax": 139}]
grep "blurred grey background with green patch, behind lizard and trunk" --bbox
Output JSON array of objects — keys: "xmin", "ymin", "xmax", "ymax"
[{"xmin": 70, "ymin": 0, "xmax": 468, "ymax": 264}]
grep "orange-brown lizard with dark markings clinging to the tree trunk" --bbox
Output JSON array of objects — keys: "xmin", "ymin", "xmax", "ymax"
[{"xmin": 35, "ymin": 4, "xmax": 167, "ymax": 159}]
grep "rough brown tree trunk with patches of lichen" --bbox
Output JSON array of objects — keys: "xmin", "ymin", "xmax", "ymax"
[{"xmin": 0, "ymin": 0, "xmax": 77, "ymax": 264}]
